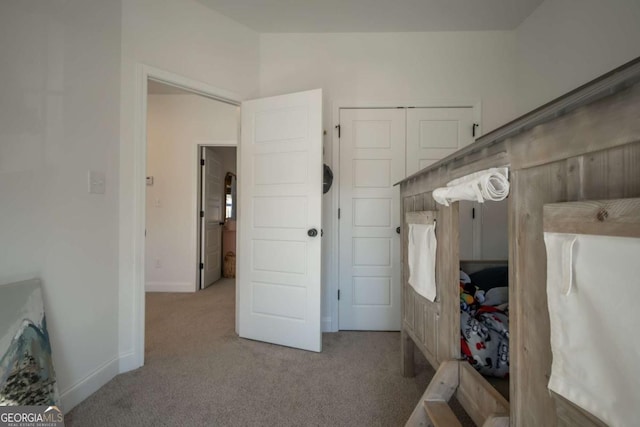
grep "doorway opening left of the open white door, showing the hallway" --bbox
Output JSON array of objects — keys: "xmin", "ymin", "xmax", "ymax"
[{"xmin": 143, "ymin": 78, "xmax": 239, "ymax": 357}]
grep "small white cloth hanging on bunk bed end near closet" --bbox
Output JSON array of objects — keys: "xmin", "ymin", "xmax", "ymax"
[{"xmin": 408, "ymin": 224, "xmax": 437, "ymax": 301}]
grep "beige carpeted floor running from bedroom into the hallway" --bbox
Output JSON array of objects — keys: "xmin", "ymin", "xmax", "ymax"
[{"xmin": 65, "ymin": 280, "xmax": 448, "ymax": 427}]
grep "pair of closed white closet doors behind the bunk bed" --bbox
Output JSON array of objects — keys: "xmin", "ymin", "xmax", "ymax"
[{"xmin": 338, "ymin": 107, "xmax": 474, "ymax": 330}]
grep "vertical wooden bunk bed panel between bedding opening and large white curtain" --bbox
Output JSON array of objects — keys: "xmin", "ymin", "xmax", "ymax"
[{"xmin": 509, "ymin": 162, "xmax": 566, "ymax": 426}]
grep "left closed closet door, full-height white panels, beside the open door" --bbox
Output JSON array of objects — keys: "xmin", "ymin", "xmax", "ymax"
[{"xmin": 339, "ymin": 108, "xmax": 406, "ymax": 330}]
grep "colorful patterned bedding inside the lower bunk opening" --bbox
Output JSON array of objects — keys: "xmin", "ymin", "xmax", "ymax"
[{"xmin": 460, "ymin": 276, "xmax": 509, "ymax": 378}]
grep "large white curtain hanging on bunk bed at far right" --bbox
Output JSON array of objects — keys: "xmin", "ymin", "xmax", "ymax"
[{"xmin": 544, "ymin": 233, "xmax": 640, "ymax": 426}]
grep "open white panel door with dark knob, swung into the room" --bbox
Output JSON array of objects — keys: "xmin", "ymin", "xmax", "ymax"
[{"xmin": 237, "ymin": 90, "xmax": 322, "ymax": 351}]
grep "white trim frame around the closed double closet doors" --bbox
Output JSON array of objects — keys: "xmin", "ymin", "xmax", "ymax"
[{"xmin": 330, "ymin": 98, "xmax": 483, "ymax": 332}]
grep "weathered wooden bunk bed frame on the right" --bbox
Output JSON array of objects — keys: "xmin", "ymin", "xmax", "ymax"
[{"xmin": 400, "ymin": 58, "xmax": 640, "ymax": 426}]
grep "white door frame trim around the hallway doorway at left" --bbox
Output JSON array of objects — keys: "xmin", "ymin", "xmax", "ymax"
[{"xmin": 129, "ymin": 63, "xmax": 242, "ymax": 372}]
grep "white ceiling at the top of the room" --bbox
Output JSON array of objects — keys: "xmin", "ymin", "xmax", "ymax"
[{"xmin": 198, "ymin": 0, "xmax": 543, "ymax": 33}]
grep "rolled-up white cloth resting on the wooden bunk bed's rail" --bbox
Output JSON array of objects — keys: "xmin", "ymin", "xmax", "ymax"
[{"xmin": 433, "ymin": 168, "xmax": 509, "ymax": 206}]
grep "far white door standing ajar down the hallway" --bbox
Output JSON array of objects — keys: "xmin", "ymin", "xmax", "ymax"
[{"xmin": 200, "ymin": 147, "xmax": 224, "ymax": 289}]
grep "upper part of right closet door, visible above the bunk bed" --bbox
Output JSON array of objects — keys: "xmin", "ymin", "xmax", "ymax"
[{"xmin": 407, "ymin": 107, "xmax": 474, "ymax": 176}]
